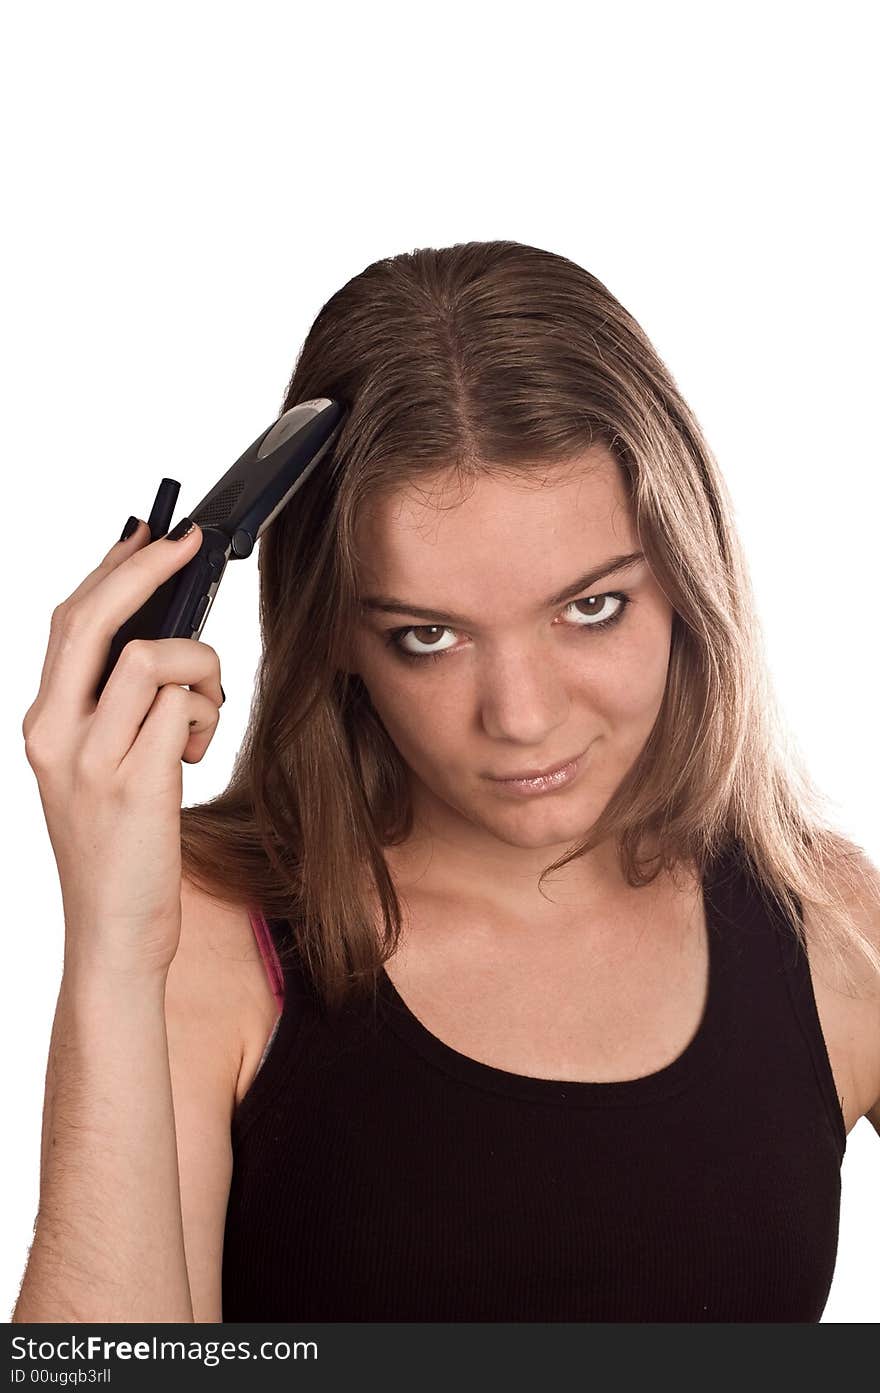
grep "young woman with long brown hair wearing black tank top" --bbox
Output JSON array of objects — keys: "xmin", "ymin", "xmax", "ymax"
[{"xmin": 14, "ymin": 241, "xmax": 880, "ymax": 1322}]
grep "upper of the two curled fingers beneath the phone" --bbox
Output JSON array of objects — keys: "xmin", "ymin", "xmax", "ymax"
[{"xmin": 79, "ymin": 638, "xmax": 221, "ymax": 772}]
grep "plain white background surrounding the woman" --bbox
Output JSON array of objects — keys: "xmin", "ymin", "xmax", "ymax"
[{"xmin": 0, "ymin": 0, "xmax": 880, "ymax": 1322}]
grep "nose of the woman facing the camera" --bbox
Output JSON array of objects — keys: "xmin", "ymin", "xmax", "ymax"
[{"xmin": 479, "ymin": 645, "xmax": 569, "ymax": 751}]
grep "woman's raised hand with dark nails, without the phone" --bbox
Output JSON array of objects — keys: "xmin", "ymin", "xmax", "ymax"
[{"xmin": 22, "ymin": 524, "xmax": 223, "ymax": 982}]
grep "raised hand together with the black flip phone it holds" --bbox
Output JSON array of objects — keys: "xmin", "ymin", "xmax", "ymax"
[{"xmin": 22, "ymin": 397, "xmax": 347, "ymax": 978}]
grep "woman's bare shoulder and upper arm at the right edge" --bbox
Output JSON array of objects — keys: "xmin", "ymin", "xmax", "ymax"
[{"xmin": 803, "ymin": 857, "xmax": 880, "ymax": 1134}]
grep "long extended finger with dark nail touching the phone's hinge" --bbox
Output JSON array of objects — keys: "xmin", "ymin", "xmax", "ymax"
[{"xmin": 43, "ymin": 525, "xmax": 202, "ymax": 723}]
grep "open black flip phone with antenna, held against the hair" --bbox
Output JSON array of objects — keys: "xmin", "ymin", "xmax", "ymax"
[{"xmin": 95, "ymin": 397, "xmax": 348, "ymax": 699}]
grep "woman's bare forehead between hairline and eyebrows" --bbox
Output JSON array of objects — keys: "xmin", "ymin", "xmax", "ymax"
[{"xmin": 355, "ymin": 447, "xmax": 638, "ymax": 596}]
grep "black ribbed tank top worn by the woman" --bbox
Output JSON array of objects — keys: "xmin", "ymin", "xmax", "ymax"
[{"xmin": 223, "ymin": 853, "xmax": 847, "ymax": 1322}]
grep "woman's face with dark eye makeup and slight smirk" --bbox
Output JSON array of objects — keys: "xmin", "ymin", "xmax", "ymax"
[{"xmin": 351, "ymin": 447, "xmax": 673, "ymax": 861}]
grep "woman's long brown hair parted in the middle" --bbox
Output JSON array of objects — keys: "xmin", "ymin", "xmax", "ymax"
[{"xmin": 181, "ymin": 241, "xmax": 880, "ymax": 1010}]
